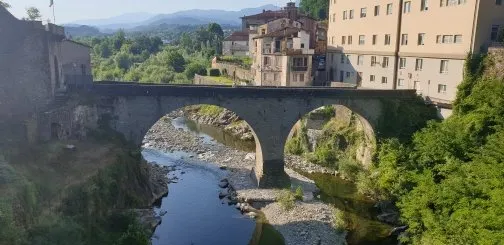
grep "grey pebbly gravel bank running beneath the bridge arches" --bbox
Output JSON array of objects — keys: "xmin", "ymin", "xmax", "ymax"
[{"xmin": 144, "ymin": 114, "xmax": 346, "ymax": 245}]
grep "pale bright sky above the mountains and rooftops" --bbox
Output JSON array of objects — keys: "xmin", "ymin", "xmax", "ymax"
[{"xmin": 6, "ymin": 0, "xmax": 289, "ymax": 24}]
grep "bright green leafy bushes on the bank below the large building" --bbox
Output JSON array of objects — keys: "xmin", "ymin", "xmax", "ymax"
[{"xmin": 370, "ymin": 53, "xmax": 504, "ymax": 244}]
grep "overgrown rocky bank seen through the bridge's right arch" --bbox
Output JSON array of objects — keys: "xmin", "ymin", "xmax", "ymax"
[{"xmin": 285, "ymin": 104, "xmax": 376, "ymax": 169}]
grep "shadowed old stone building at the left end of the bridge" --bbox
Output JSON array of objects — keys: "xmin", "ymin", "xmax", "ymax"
[{"xmin": 0, "ymin": 6, "xmax": 92, "ymax": 144}]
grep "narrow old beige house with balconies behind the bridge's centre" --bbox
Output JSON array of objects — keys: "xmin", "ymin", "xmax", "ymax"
[{"xmin": 251, "ymin": 22, "xmax": 315, "ymax": 87}]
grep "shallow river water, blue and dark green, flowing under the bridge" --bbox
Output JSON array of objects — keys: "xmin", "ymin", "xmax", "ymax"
[{"xmin": 142, "ymin": 117, "xmax": 397, "ymax": 245}]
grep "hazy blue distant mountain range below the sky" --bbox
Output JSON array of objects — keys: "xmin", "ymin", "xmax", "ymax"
[{"xmin": 65, "ymin": 4, "xmax": 280, "ymax": 33}]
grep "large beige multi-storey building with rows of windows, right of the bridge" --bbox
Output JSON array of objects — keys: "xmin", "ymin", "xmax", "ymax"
[{"xmin": 327, "ymin": 0, "xmax": 504, "ymax": 116}]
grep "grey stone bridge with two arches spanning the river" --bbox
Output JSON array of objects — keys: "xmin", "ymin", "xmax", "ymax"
[{"xmin": 90, "ymin": 83, "xmax": 416, "ymax": 188}]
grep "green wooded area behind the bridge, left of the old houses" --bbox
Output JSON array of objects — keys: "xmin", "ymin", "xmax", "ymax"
[{"xmin": 79, "ymin": 23, "xmax": 224, "ymax": 83}]
